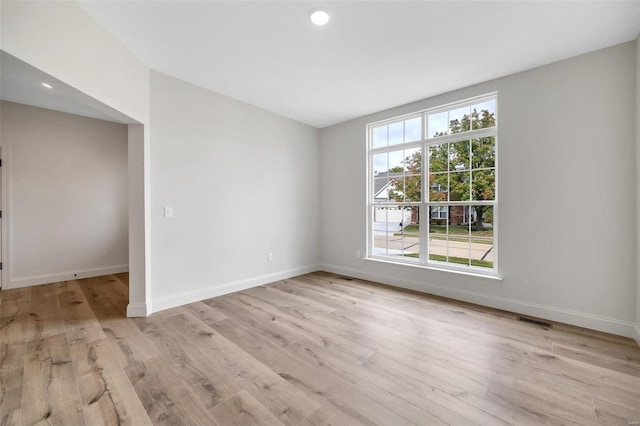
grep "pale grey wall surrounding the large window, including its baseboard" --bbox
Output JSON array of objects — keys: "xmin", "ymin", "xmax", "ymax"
[{"xmin": 320, "ymin": 42, "xmax": 637, "ymax": 336}]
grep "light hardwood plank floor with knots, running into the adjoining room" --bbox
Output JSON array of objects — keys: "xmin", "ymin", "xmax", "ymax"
[{"xmin": 0, "ymin": 273, "xmax": 640, "ymax": 426}]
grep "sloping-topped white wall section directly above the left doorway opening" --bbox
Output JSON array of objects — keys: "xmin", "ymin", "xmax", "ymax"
[{"xmin": 0, "ymin": 1, "xmax": 149, "ymax": 122}]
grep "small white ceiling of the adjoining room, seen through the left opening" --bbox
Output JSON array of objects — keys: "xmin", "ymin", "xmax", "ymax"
[{"xmin": 0, "ymin": 50, "xmax": 135, "ymax": 123}]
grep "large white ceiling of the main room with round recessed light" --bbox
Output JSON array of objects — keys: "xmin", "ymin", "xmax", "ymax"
[{"xmin": 80, "ymin": 0, "xmax": 640, "ymax": 127}]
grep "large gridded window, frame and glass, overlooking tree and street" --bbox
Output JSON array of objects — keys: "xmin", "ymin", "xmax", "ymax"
[{"xmin": 367, "ymin": 94, "xmax": 497, "ymax": 273}]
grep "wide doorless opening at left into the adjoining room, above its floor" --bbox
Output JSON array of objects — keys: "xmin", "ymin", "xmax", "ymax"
[{"xmin": 0, "ymin": 51, "xmax": 148, "ymax": 316}]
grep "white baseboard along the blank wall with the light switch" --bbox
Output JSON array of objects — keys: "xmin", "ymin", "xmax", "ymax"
[{"xmin": 151, "ymin": 265, "xmax": 320, "ymax": 312}]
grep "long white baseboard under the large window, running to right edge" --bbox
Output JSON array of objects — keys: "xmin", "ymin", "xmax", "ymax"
[{"xmin": 320, "ymin": 265, "xmax": 640, "ymax": 344}]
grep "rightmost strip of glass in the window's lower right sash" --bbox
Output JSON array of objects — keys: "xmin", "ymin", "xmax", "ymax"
[{"xmin": 470, "ymin": 206, "xmax": 494, "ymax": 268}]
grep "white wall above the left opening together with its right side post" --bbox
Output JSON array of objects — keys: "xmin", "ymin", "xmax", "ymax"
[{"xmin": 0, "ymin": 1, "xmax": 151, "ymax": 316}]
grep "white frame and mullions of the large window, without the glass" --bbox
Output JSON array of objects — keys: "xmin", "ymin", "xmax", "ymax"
[{"xmin": 366, "ymin": 92, "xmax": 499, "ymax": 277}]
